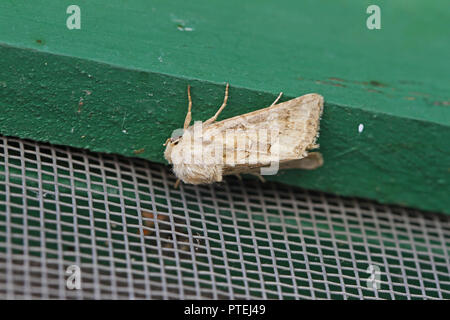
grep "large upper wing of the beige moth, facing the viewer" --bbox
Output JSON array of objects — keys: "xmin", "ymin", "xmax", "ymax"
[{"xmin": 202, "ymin": 93, "xmax": 323, "ymax": 175}]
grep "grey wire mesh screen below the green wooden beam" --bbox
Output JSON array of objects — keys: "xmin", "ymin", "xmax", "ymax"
[{"xmin": 0, "ymin": 137, "xmax": 450, "ymax": 299}]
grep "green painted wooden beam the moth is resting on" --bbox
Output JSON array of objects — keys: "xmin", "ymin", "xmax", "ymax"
[{"xmin": 0, "ymin": 0, "xmax": 450, "ymax": 214}]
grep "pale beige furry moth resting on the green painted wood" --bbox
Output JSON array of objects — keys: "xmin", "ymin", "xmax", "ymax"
[{"xmin": 164, "ymin": 84, "xmax": 324, "ymax": 186}]
